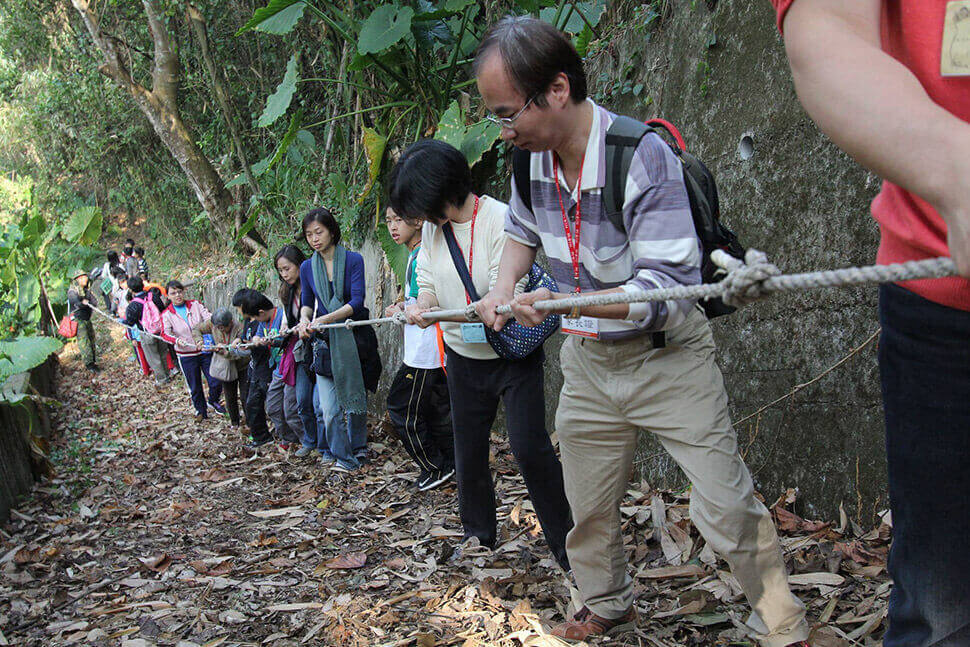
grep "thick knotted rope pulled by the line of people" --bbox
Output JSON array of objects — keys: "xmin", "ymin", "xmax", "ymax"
[{"xmin": 91, "ymin": 249, "xmax": 957, "ymax": 351}]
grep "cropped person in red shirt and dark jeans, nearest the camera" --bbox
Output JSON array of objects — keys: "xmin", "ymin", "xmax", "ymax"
[{"xmin": 772, "ymin": 0, "xmax": 970, "ymax": 647}]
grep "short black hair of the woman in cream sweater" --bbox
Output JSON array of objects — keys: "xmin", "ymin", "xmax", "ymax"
[{"xmin": 387, "ymin": 139, "xmax": 472, "ymax": 222}]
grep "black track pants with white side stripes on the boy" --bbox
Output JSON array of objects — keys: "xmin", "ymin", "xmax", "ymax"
[{"xmin": 387, "ymin": 364, "xmax": 455, "ymax": 472}]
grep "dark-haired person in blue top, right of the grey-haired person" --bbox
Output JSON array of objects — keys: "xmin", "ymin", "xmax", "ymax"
[{"xmin": 233, "ymin": 289, "xmax": 292, "ymax": 449}]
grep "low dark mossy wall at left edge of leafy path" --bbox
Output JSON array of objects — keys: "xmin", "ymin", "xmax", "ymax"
[{"xmin": 0, "ymin": 356, "xmax": 57, "ymax": 523}]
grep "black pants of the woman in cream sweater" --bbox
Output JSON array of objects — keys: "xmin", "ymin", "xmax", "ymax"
[{"xmin": 447, "ymin": 348, "xmax": 572, "ymax": 570}]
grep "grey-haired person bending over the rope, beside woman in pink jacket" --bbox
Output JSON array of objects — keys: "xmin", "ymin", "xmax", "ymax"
[{"xmin": 192, "ymin": 308, "xmax": 250, "ymax": 427}]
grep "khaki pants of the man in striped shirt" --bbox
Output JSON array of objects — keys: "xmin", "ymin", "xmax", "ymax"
[{"xmin": 556, "ymin": 310, "xmax": 808, "ymax": 647}]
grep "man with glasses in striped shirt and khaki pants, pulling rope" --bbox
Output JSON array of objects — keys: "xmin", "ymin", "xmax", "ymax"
[{"xmin": 472, "ymin": 17, "xmax": 808, "ymax": 647}]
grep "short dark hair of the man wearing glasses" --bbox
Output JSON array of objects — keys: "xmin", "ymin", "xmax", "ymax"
[{"xmin": 473, "ymin": 16, "xmax": 586, "ymax": 107}]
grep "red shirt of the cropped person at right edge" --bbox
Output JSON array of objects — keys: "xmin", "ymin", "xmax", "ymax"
[{"xmin": 771, "ymin": 0, "xmax": 970, "ymax": 310}]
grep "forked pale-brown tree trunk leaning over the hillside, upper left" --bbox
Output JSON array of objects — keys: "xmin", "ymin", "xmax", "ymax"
[{"xmin": 71, "ymin": 0, "xmax": 265, "ymax": 252}]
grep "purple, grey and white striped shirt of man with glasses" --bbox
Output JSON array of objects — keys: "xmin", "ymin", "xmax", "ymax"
[{"xmin": 505, "ymin": 100, "xmax": 701, "ymax": 340}]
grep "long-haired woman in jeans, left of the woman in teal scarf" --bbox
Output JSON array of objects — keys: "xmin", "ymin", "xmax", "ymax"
[{"xmin": 273, "ymin": 245, "xmax": 326, "ymax": 458}]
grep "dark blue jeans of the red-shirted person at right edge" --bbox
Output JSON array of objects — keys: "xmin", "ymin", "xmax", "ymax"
[{"xmin": 879, "ymin": 285, "xmax": 970, "ymax": 647}]
